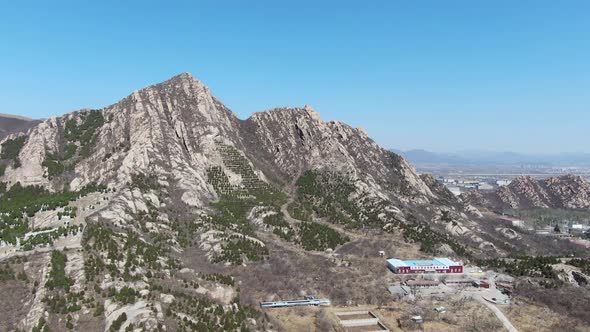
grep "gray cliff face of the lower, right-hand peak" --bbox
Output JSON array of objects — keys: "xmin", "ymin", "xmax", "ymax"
[{"xmin": 243, "ymin": 107, "xmax": 434, "ymax": 202}]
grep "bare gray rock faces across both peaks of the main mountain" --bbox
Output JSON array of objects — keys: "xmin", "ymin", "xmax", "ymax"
[{"xmin": 5, "ymin": 74, "xmax": 448, "ymax": 207}]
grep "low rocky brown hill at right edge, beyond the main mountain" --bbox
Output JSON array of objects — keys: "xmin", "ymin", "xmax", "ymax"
[{"xmin": 465, "ymin": 175, "xmax": 590, "ymax": 209}]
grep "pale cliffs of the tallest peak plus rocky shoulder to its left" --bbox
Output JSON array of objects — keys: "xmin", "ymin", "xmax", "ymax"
[{"xmin": 1, "ymin": 74, "xmax": 238, "ymax": 205}]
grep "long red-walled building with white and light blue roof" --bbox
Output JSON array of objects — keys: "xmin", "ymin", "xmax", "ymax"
[{"xmin": 387, "ymin": 258, "xmax": 463, "ymax": 274}]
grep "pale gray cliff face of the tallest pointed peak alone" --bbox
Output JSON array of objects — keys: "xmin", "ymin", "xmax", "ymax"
[{"xmin": 78, "ymin": 74, "xmax": 243, "ymax": 205}]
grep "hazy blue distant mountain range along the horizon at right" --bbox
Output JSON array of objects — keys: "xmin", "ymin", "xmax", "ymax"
[{"xmin": 392, "ymin": 149, "xmax": 590, "ymax": 167}]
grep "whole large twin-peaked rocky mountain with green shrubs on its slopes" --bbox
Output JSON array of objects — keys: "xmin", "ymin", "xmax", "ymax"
[{"xmin": 0, "ymin": 74, "xmax": 483, "ymax": 330}]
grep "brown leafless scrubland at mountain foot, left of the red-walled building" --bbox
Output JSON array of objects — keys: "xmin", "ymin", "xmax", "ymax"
[{"xmin": 182, "ymin": 234, "xmax": 419, "ymax": 306}]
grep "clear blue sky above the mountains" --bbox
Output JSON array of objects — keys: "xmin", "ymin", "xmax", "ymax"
[{"xmin": 0, "ymin": 0, "xmax": 590, "ymax": 153}]
